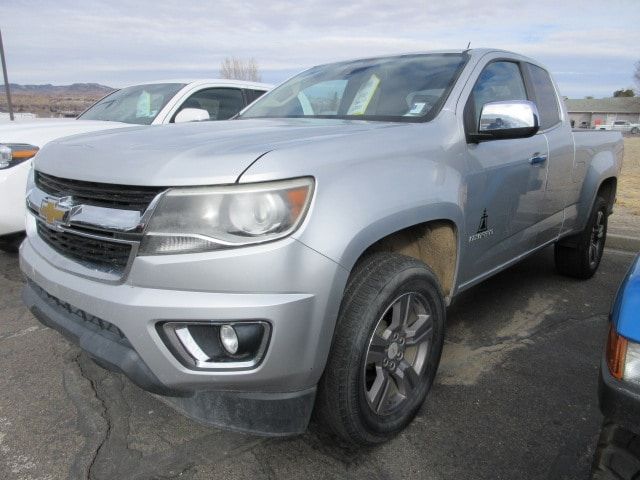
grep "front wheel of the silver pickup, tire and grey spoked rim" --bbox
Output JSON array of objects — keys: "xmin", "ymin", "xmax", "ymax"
[{"xmin": 316, "ymin": 253, "xmax": 445, "ymax": 445}]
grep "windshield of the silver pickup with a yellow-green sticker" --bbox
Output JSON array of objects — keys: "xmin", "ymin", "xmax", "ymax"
[{"xmin": 240, "ymin": 53, "xmax": 467, "ymax": 122}]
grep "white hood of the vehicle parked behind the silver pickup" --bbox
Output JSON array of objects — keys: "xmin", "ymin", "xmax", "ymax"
[{"xmin": 0, "ymin": 118, "xmax": 131, "ymax": 148}]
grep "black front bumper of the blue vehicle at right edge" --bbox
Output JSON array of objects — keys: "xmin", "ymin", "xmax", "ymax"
[{"xmin": 598, "ymin": 357, "xmax": 640, "ymax": 434}]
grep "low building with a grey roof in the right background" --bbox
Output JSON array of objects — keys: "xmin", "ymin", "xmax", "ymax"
[{"xmin": 565, "ymin": 97, "xmax": 640, "ymax": 128}]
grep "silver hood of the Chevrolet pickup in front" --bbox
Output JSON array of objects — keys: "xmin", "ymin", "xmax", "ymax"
[{"xmin": 35, "ymin": 119, "xmax": 398, "ymax": 186}]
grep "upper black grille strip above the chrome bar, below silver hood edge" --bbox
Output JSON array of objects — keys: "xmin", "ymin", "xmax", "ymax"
[{"xmin": 35, "ymin": 172, "xmax": 166, "ymax": 212}]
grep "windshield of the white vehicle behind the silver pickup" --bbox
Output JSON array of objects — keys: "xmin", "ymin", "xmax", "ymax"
[{"xmin": 78, "ymin": 83, "xmax": 185, "ymax": 125}]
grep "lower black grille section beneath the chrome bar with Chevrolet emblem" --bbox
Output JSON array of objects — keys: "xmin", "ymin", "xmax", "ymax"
[{"xmin": 37, "ymin": 221, "xmax": 131, "ymax": 274}]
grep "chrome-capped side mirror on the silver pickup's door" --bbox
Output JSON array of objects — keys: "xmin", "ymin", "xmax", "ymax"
[{"xmin": 470, "ymin": 100, "xmax": 540, "ymax": 142}]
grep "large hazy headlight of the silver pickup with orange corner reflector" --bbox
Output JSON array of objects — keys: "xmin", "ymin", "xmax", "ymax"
[{"xmin": 139, "ymin": 178, "xmax": 314, "ymax": 255}]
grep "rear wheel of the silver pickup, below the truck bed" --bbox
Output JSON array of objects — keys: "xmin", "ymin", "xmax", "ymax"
[{"xmin": 555, "ymin": 196, "xmax": 609, "ymax": 280}]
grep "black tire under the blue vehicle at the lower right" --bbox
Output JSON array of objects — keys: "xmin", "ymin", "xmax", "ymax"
[{"xmin": 591, "ymin": 420, "xmax": 640, "ymax": 480}]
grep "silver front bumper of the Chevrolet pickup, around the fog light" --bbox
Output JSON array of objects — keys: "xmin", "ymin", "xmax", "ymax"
[{"xmin": 20, "ymin": 234, "xmax": 348, "ymax": 434}]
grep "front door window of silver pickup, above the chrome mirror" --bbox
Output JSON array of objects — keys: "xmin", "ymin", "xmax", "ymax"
[{"xmin": 469, "ymin": 62, "xmax": 527, "ymax": 126}]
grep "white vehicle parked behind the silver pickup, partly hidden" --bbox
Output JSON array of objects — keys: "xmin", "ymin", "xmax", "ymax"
[{"xmin": 0, "ymin": 80, "xmax": 271, "ymax": 250}]
